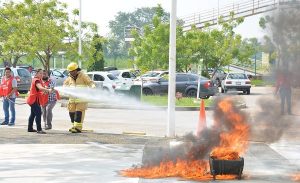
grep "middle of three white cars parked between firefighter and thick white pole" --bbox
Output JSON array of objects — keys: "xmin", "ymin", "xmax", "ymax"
[{"xmin": 109, "ymin": 70, "xmax": 136, "ymax": 90}]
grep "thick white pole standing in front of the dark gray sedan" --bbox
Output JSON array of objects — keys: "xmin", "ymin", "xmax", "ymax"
[{"xmin": 167, "ymin": 0, "xmax": 177, "ymax": 137}]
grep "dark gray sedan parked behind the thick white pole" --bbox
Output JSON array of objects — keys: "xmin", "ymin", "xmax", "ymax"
[{"xmin": 143, "ymin": 73, "xmax": 218, "ymax": 98}]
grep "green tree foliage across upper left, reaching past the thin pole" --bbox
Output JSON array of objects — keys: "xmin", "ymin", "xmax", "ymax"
[{"xmin": 0, "ymin": 0, "xmax": 105, "ymax": 70}]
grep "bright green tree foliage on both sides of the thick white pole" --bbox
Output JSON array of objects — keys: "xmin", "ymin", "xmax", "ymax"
[{"xmin": 129, "ymin": 10, "xmax": 250, "ymax": 73}]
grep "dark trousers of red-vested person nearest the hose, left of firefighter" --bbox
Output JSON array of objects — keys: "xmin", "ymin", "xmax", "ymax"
[{"xmin": 28, "ymin": 102, "xmax": 42, "ymax": 131}]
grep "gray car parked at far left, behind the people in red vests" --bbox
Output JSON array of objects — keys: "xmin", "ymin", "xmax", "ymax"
[{"xmin": 0, "ymin": 68, "xmax": 31, "ymax": 94}]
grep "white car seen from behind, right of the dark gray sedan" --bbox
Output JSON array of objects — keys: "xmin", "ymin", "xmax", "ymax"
[{"xmin": 221, "ymin": 73, "xmax": 251, "ymax": 95}]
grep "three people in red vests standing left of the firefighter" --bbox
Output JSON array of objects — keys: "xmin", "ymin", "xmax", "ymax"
[{"xmin": 0, "ymin": 67, "xmax": 59, "ymax": 133}]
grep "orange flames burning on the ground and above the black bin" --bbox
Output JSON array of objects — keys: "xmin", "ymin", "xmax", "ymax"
[{"xmin": 121, "ymin": 98, "xmax": 249, "ymax": 180}]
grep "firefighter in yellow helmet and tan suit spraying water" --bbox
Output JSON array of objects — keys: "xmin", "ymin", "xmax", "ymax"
[{"xmin": 64, "ymin": 62, "xmax": 96, "ymax": 133}]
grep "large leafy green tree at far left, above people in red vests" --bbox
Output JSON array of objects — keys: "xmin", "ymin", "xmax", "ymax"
[{"xmin": 0, "ymin": 0, "xmax": 72, "ymax": 70}]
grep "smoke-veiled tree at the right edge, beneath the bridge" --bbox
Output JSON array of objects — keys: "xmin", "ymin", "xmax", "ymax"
[{"xmin": 259, "ymin": 5, "xmax": 300, "ymax": 68}]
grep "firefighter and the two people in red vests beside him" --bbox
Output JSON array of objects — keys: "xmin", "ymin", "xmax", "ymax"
[{"xmin": 27, "ymin": 62, "xmax": 96, "ymax": 134}]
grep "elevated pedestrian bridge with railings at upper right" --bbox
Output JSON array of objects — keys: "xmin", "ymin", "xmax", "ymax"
[{"xmin": 180, "ymin": 0, "xmax": 300, "ymax": 31}]
